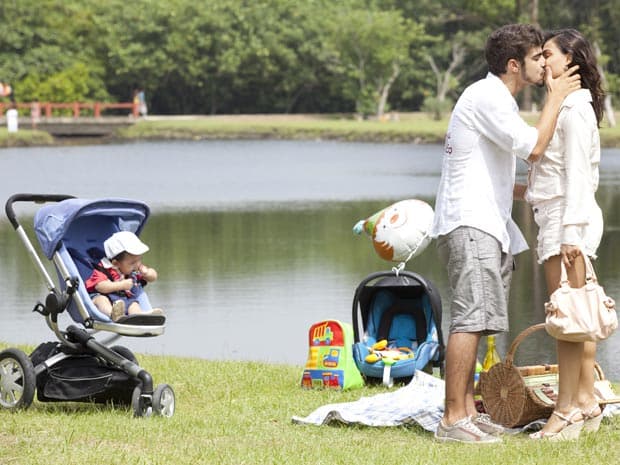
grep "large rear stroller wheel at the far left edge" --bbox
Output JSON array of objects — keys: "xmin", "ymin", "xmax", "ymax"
[{"xmin": 0, "ymin": 349, "xmax": 37, "ymax": 410}]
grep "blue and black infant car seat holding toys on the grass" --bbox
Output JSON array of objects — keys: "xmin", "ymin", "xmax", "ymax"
[{"xmin": 353, "ymin": 270, "xmax": 445, "ymax": 387}]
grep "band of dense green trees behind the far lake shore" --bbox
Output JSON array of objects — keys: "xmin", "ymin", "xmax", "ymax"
[{"xmin": 0, "ymin": 0, "xmax": 620, "ymax": 116}]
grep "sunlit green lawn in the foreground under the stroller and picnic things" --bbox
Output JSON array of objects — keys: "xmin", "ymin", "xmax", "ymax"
[{"xmin": 0, "ymin": 344, "xmax": 620, "ymax": 465}]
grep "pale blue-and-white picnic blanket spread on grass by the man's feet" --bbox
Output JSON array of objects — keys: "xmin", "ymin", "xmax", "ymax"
[{"xmin": 293, "ymin": 371, "xmax": 445, "ymax": 432}]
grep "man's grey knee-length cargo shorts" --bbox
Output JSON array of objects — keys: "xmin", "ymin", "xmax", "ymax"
[{"xmin": 437, "ymin": 226, "xmax": 514, "ymax": 334}]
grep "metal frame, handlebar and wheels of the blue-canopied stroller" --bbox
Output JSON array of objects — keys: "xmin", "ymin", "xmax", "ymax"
[{"xmin": 0, "ymin": 194, "xmax": 175, "ymax": 417}]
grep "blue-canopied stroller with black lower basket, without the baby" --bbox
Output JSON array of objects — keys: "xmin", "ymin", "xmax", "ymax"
[{"xmin": 0, "ymin": 194, "xmax": 175, "ymax": 417}]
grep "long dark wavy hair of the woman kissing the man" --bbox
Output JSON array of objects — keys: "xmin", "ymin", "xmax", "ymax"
[{"xmin": 545, "ymin": 29, "xmax": 605, "ymax": 126}]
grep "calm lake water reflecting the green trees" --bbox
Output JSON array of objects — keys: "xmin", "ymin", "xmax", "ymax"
[{"xmin": 0, "ymin": 141, "xmax": 620, "ymax": 380}]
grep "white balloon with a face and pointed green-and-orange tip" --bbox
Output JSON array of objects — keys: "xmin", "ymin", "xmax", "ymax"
[{"xmin": 353, "ymin": 199, "xmax": 434, "ymax": 268}]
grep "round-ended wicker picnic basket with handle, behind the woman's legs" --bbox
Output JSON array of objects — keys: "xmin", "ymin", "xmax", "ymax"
[{"xmin": 479, "ymin": 323, "xmax": 605, "ymax": 428}]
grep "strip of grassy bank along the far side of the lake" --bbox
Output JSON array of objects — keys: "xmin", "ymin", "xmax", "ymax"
[{"xmin": 0, "ymin": 112, "xmax": 620, "ymax": 149}]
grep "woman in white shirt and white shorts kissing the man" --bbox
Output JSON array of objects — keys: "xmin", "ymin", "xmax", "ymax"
[{"xmin": 525, "ymin": 29, "xmax": 604, "ymax": 440}]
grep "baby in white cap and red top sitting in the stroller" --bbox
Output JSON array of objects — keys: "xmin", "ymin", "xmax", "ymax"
[{"xmin": 86, "ymin": 231, "xmax": 164, "ymax": 321}]
